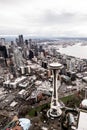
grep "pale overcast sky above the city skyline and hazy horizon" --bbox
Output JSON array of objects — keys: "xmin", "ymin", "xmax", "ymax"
[{"xmin": 0, "ymin": 0, "xmax": 87, "ymax": 37}]
